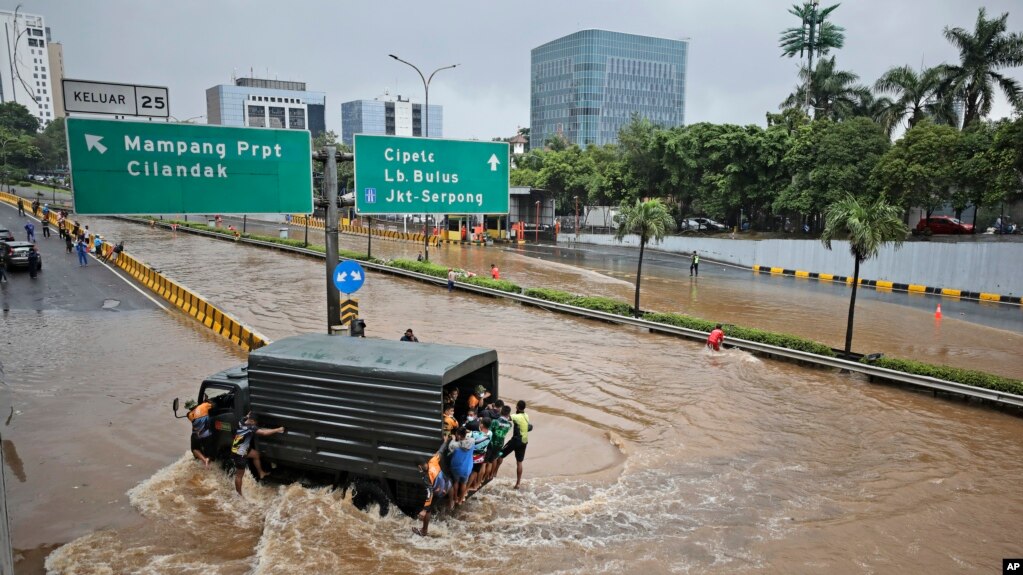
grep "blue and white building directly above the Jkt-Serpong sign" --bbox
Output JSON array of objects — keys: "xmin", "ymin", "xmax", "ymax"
[{"xmin": 341, "ymin": 94, "xmax": 444, "ymax": 145}]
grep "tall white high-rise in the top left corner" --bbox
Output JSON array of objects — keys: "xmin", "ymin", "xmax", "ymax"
[{"xmin": 0, "ymin": 10, "xmax": 60, "ymax": 126}]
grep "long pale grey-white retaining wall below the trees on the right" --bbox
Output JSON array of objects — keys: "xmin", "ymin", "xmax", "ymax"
[{"xmin": 572, "ymin": 233, "xmax": 1023, "ymax": 296}]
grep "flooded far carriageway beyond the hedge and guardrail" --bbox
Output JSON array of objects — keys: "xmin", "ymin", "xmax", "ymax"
[{"xmin": 180, "ymin": 214, "xmax": 1023, "ymax": 379}]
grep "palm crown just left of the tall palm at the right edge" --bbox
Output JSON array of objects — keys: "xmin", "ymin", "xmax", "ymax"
[{"xmin": 874, "ymin": 65, "xmax": 957, "ymax": 135}]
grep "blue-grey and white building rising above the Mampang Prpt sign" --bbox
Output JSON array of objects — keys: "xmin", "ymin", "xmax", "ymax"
[{"xmin": 206, "ymin": 78, "xmax": 326, "ymax": 137}]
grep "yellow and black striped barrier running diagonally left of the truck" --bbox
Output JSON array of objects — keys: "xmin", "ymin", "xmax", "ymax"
[{"xmin": 0, "ymin": 192, "xmax": 270, "ymax": 351}]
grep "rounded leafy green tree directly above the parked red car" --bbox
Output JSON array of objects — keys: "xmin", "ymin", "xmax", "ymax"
[{"xmin": 872, "ymin": 121, "xmax": 959, "ymax": 218}]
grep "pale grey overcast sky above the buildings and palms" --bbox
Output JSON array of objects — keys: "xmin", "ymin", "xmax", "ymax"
[{"xmin": 14, "ymin": 0, "xmax": 1023, "ymax": 139}]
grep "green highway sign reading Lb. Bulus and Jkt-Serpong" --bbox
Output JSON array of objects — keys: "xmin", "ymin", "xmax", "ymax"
[{"xmin": 354, "ymin": 134, "xmax": 508, "ymax": 214}]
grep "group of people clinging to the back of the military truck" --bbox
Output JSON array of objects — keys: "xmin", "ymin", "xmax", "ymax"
[{"xmin": 414, "ymin": 386, "xmax": 533, "ymax": 535}]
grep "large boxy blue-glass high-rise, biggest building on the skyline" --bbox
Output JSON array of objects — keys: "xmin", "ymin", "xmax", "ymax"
[{"xmin": 529, "ymin": 30, "xmax": 688, "ymax": 148}]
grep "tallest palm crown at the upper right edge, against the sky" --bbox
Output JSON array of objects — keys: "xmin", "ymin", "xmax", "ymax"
[{"xmin": 941, "ymin": 8, "xmax": 1023, "ymax": 127}]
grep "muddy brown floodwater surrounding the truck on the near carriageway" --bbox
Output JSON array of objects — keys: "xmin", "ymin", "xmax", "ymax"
[{"xmin": 4, "ymin": 220, "xmax": 1023, "ymax": 573}]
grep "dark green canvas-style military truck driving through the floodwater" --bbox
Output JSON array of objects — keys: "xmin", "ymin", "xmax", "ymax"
[{"xmin": 173, "ymin": 334, "xmax": 499, "ymax": 516}]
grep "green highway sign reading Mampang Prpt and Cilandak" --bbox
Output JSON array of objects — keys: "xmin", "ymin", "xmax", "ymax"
[{"xmin": 66, "ymin": 118, "xmax": 313, "ymax": 215}]
